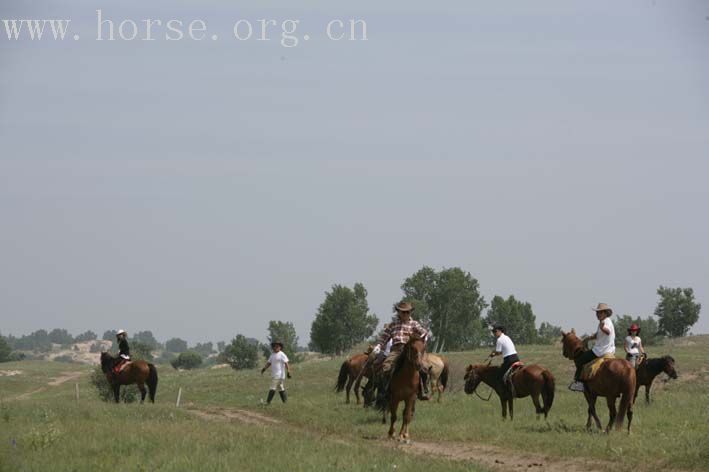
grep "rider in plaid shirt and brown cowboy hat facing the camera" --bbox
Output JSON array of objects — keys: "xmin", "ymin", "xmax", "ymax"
[{"xmin": 373, "ymin": 302, "xmax": 428, "ymax": 400}]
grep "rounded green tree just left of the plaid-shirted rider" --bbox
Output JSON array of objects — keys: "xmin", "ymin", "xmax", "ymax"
[{"xmin": 310, "ymin": 283, "xmax": 379, "ymax": 355}]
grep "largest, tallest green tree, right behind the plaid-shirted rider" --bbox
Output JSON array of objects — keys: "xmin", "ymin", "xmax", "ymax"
[{"xmin": 401, "ymin": 266, "xmax": 486, "ymax": 352}]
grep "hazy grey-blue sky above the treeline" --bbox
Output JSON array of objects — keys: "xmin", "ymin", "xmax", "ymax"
[{"xmin": 0, "ymin": 0, "xmax": 709, "ymax": 344}]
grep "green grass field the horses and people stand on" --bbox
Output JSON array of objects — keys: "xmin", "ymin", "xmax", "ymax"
[{"xmin": 0, "ymin": 336, "xmax": 709, "ymax": 471}]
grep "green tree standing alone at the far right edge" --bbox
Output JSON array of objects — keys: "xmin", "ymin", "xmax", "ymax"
[{"xmin": 655, "ymin": 286, "xmax": 702, "ymax": 338}]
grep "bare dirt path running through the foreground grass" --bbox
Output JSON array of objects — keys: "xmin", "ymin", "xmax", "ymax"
[{"xmin": 186, "ymin": 405, "xmax": 613, "ymax": 472}]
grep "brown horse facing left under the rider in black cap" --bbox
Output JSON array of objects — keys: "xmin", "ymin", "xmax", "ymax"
[{"xmin": 465, "ymin": 364, "xmax": 555, "ymax": 420}]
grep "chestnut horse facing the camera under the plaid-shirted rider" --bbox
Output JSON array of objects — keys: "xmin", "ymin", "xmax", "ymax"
[{"xmin": 377, "ymin": 336, "xmax": 426, "ymax": 443}]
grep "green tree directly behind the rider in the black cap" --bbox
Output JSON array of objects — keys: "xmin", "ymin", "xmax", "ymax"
[{"xmin": 486, "ymin": 295, "xmax": 537, "ymax": 344}]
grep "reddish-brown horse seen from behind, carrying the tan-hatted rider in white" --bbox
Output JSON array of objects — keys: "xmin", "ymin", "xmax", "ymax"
[{"xmin": 561, "ymin": 329, "xmax": 637, "ymax": 433}]
